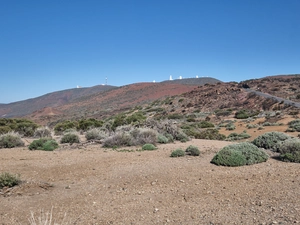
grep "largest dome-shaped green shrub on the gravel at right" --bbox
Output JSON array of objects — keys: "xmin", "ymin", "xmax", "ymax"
[{"xmin": 211, "ymin": 142, "xmax": 269, "ymax": 166}]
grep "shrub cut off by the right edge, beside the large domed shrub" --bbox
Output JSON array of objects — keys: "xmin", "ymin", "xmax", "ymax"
[{"xmin": 279, "ymin": 138, "xmax": 300, "ymax": 163}]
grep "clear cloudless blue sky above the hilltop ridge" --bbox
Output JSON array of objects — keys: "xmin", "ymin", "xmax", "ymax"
[{"xmin": 0, "ymin": 0, "xmax": 300, "ymax": 103}]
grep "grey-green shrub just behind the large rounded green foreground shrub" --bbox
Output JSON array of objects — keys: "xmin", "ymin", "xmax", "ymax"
[{"xmin": 252, "ymin": 131, "xmax": 291, "ymax": 151}]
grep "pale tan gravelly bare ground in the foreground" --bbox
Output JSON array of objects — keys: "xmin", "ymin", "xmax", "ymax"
[{"xmin": 0, "ymin": 140, "xmax": 300, "ymax": 225}]
